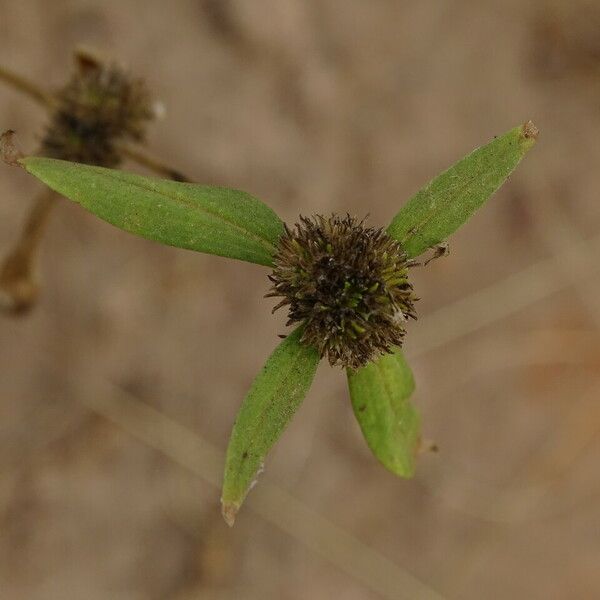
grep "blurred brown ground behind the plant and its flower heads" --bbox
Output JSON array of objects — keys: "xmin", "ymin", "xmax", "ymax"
[{"xmin": 0, "ymin": 0, "xmax": 600, "ymax": 600}]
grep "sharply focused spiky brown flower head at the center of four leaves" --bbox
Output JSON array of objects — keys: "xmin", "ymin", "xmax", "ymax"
[{"xmin": 268, "ymin": 215, "xmax": 416, "ymax": 369}]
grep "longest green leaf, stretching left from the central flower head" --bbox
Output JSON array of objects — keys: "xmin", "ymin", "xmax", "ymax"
[{"xmin": 20, "ymin": 157, "xmax": 283, "ymax": 266}]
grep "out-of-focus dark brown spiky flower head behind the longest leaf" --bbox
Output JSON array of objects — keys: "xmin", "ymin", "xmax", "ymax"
[{"xmin": 40, "ymin": 52, "xmax": 154, "ymax": 167}]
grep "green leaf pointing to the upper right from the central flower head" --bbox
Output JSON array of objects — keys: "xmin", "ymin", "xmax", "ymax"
[{"xmin": 387, "ymin": 121, "xmax": 538, "ymax": 257}]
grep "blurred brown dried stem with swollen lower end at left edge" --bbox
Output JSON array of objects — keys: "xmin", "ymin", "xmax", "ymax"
[{"xmin": 0, "ymin": 189, "xmax": 56, "ymax": 315}]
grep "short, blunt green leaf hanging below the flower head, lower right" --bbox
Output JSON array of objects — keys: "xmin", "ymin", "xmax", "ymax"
[{"xmin": 348, "ymin": 348, "xmax": 420, "ymax": 477}]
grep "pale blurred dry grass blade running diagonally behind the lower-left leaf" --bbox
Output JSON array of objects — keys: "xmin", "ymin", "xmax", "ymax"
[{"xmin": 74, "ymin": 373, "xmax": 443, "ymax": 600}]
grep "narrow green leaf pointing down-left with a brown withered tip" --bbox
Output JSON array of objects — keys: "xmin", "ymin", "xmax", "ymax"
[{"xmin": 221, "ymin": 328, "xmax": 319, "ymax": 525}]
